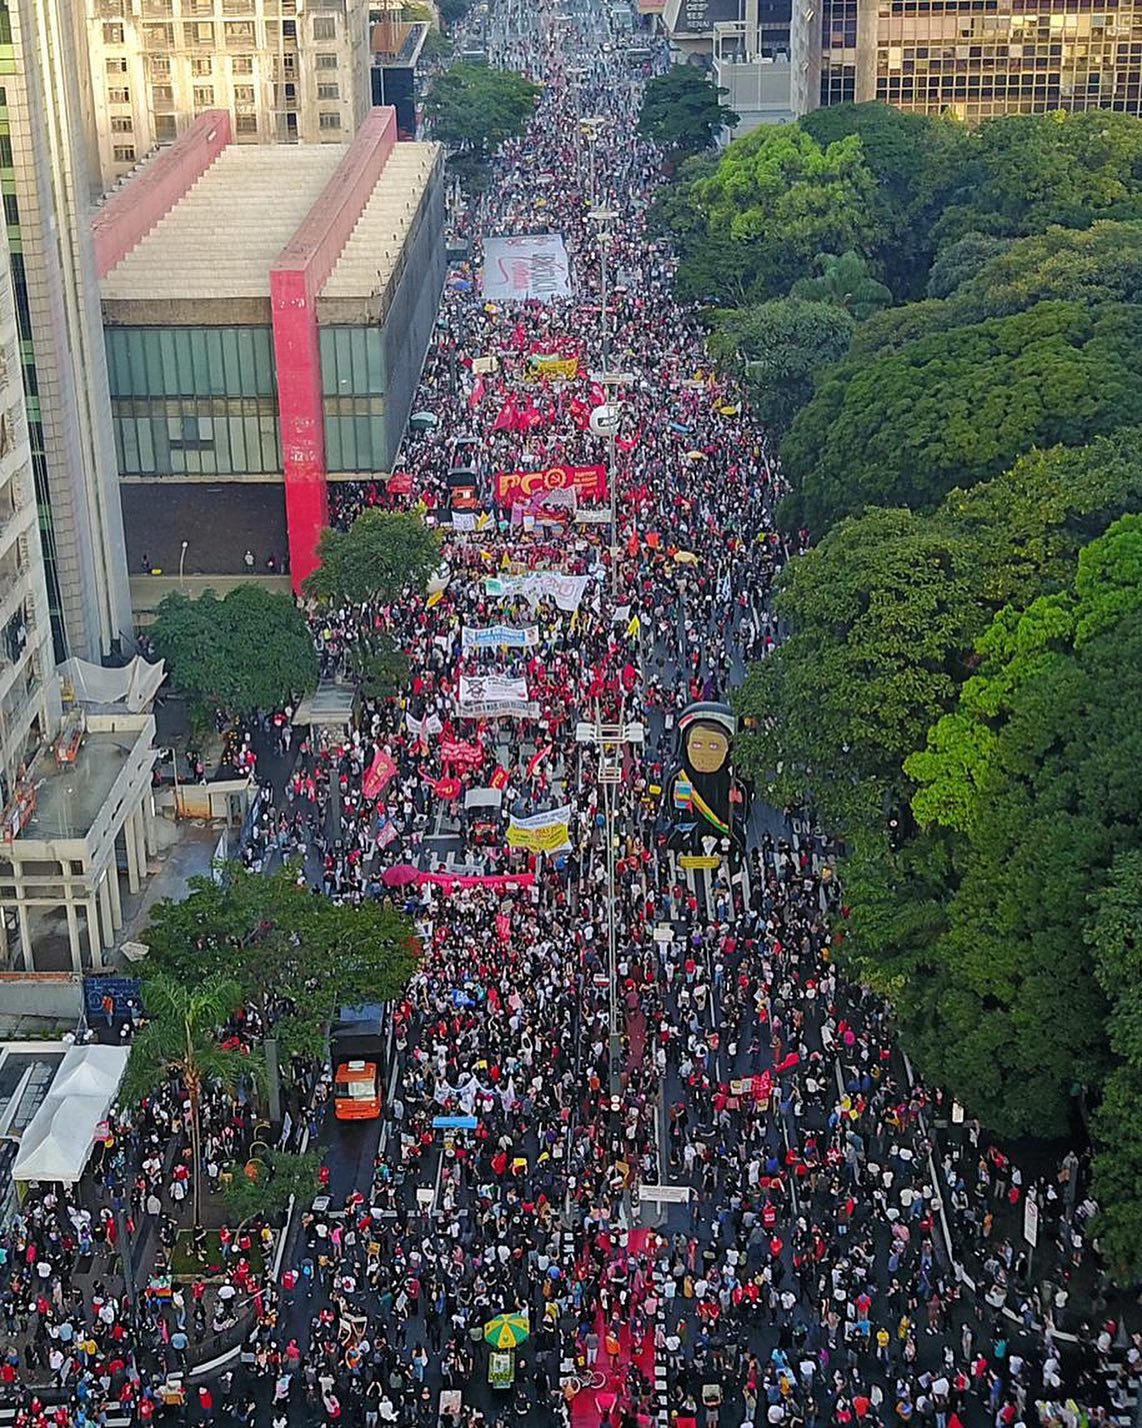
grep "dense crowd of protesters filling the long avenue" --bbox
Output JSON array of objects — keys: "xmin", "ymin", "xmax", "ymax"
[{"xmin": 0, "ymin": 0, "xmax": 1139, "ymax": 1428}]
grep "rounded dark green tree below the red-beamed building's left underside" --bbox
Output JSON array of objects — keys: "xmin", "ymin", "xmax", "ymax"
[{"xmin": 148, "ymin": 584, "xmax": 317, "ymax": 718}]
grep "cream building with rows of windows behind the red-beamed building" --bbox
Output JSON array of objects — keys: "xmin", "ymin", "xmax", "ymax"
[{"xmin": 91, "ymin": 0, "xmax": 371, "ymax": 188}]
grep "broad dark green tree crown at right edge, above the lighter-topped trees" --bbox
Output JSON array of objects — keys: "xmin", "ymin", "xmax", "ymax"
[{"xmin": 781, "ymin": 303, "xmax": 1142, "ymax": 531}]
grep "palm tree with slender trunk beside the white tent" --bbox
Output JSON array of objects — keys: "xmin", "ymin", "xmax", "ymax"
[{"xmin": 123, "ymin": 972, "xmax": 261, "ymax": 1225}]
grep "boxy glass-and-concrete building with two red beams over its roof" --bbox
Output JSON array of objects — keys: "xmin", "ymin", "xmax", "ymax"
[{"xmin": 94, "ymin": 109, "xmax": 445, "ymax": 613}]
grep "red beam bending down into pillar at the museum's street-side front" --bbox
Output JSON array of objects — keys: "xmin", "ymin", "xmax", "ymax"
[{"xmin": 270, "ymin": 109, "xmax": 397, "ymax": 591}]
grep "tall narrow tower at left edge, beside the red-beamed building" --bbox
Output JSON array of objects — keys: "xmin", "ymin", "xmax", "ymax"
[{"xmin": 0, "ymin": 0, "xmax": 131, "ymax": 660}]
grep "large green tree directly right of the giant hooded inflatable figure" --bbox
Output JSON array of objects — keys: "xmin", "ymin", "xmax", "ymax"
[{"xmin": 738, "ymin": 510, "xmax": 984, "ymax": 830}]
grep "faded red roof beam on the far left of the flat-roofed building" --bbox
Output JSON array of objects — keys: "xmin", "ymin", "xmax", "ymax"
[{"xmin": 91, "ymin": 109, "xmax": 230, "ymax": 277}]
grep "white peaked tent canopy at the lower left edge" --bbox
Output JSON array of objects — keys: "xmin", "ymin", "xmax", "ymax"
[{"xmin": 11, "ymin": 1047, "xmax": 131, "ymax": 1185}]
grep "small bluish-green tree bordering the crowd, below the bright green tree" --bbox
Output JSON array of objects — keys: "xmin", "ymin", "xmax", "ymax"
[{"xmin": 708, "ymin": 297, "xmax": 857, "ymax": 433}]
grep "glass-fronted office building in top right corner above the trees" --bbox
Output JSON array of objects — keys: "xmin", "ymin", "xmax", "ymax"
[{"xmin": 795, "ymin": 0, "xmax": 1142, "ymax": 123}]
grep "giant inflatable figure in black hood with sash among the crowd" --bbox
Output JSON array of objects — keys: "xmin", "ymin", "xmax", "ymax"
[{"xmin": 662, "ymin": 703, "xmax": 748, "ymax": 855}]
